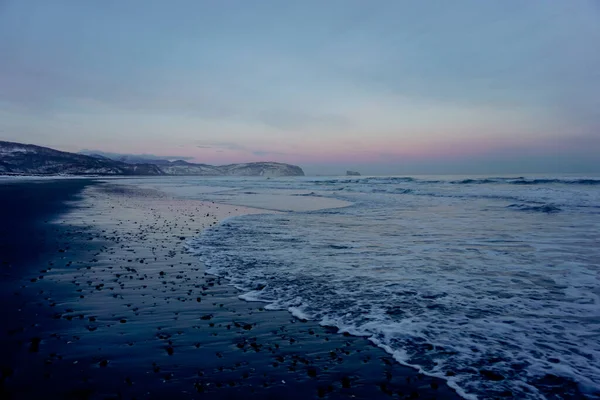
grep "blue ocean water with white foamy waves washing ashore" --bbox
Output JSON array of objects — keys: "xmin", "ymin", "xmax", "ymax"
[{"xmin": 118, "ymin": 176, "xmax": 600, "ymax": 399}]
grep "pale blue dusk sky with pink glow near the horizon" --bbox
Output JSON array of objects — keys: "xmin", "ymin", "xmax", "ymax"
[{"xmin": 0, "ymin": 0, "xmax": 600, "ymax": 174}]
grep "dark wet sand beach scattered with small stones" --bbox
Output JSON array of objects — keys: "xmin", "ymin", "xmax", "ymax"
[{"xmin": 0, "ymin": 180, "xmax": 458, "ymax": 399}]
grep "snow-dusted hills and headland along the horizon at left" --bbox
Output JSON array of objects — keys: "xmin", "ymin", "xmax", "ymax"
[{"xmin": 0, "ymin": 141, "xmax": 304, "ymax": 177}]
